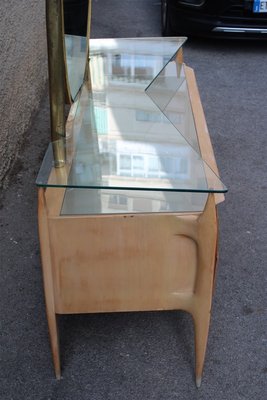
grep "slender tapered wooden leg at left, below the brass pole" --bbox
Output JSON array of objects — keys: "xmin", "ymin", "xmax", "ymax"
[{"xmin": 38, "ymin": 188, "xmax": 61, "ymax": 379}]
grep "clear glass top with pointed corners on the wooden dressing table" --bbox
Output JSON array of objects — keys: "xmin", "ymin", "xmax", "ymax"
[{"xmin": 36, "ymin": 38, "xmax": 227, "ymax": 192}]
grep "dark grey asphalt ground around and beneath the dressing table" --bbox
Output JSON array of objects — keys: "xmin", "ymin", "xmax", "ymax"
[{"xmin": 0, "ymin": 0, "xmax": 267, "ymax": 400}]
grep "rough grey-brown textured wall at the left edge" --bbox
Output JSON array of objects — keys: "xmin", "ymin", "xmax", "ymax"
[{"xmin": 0, "ymin": 0, "xmax": 47, "ymax": 188}]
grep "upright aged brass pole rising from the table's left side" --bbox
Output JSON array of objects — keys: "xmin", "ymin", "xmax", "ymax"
[{"xmin": 46, "ymin": 0, "xmax": 66, "ymax": 167}]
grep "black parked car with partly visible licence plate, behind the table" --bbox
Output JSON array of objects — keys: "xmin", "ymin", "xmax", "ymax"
[{"xmin": 161, "ymin": 0, "xmax": 267, "ymax": 39}]
